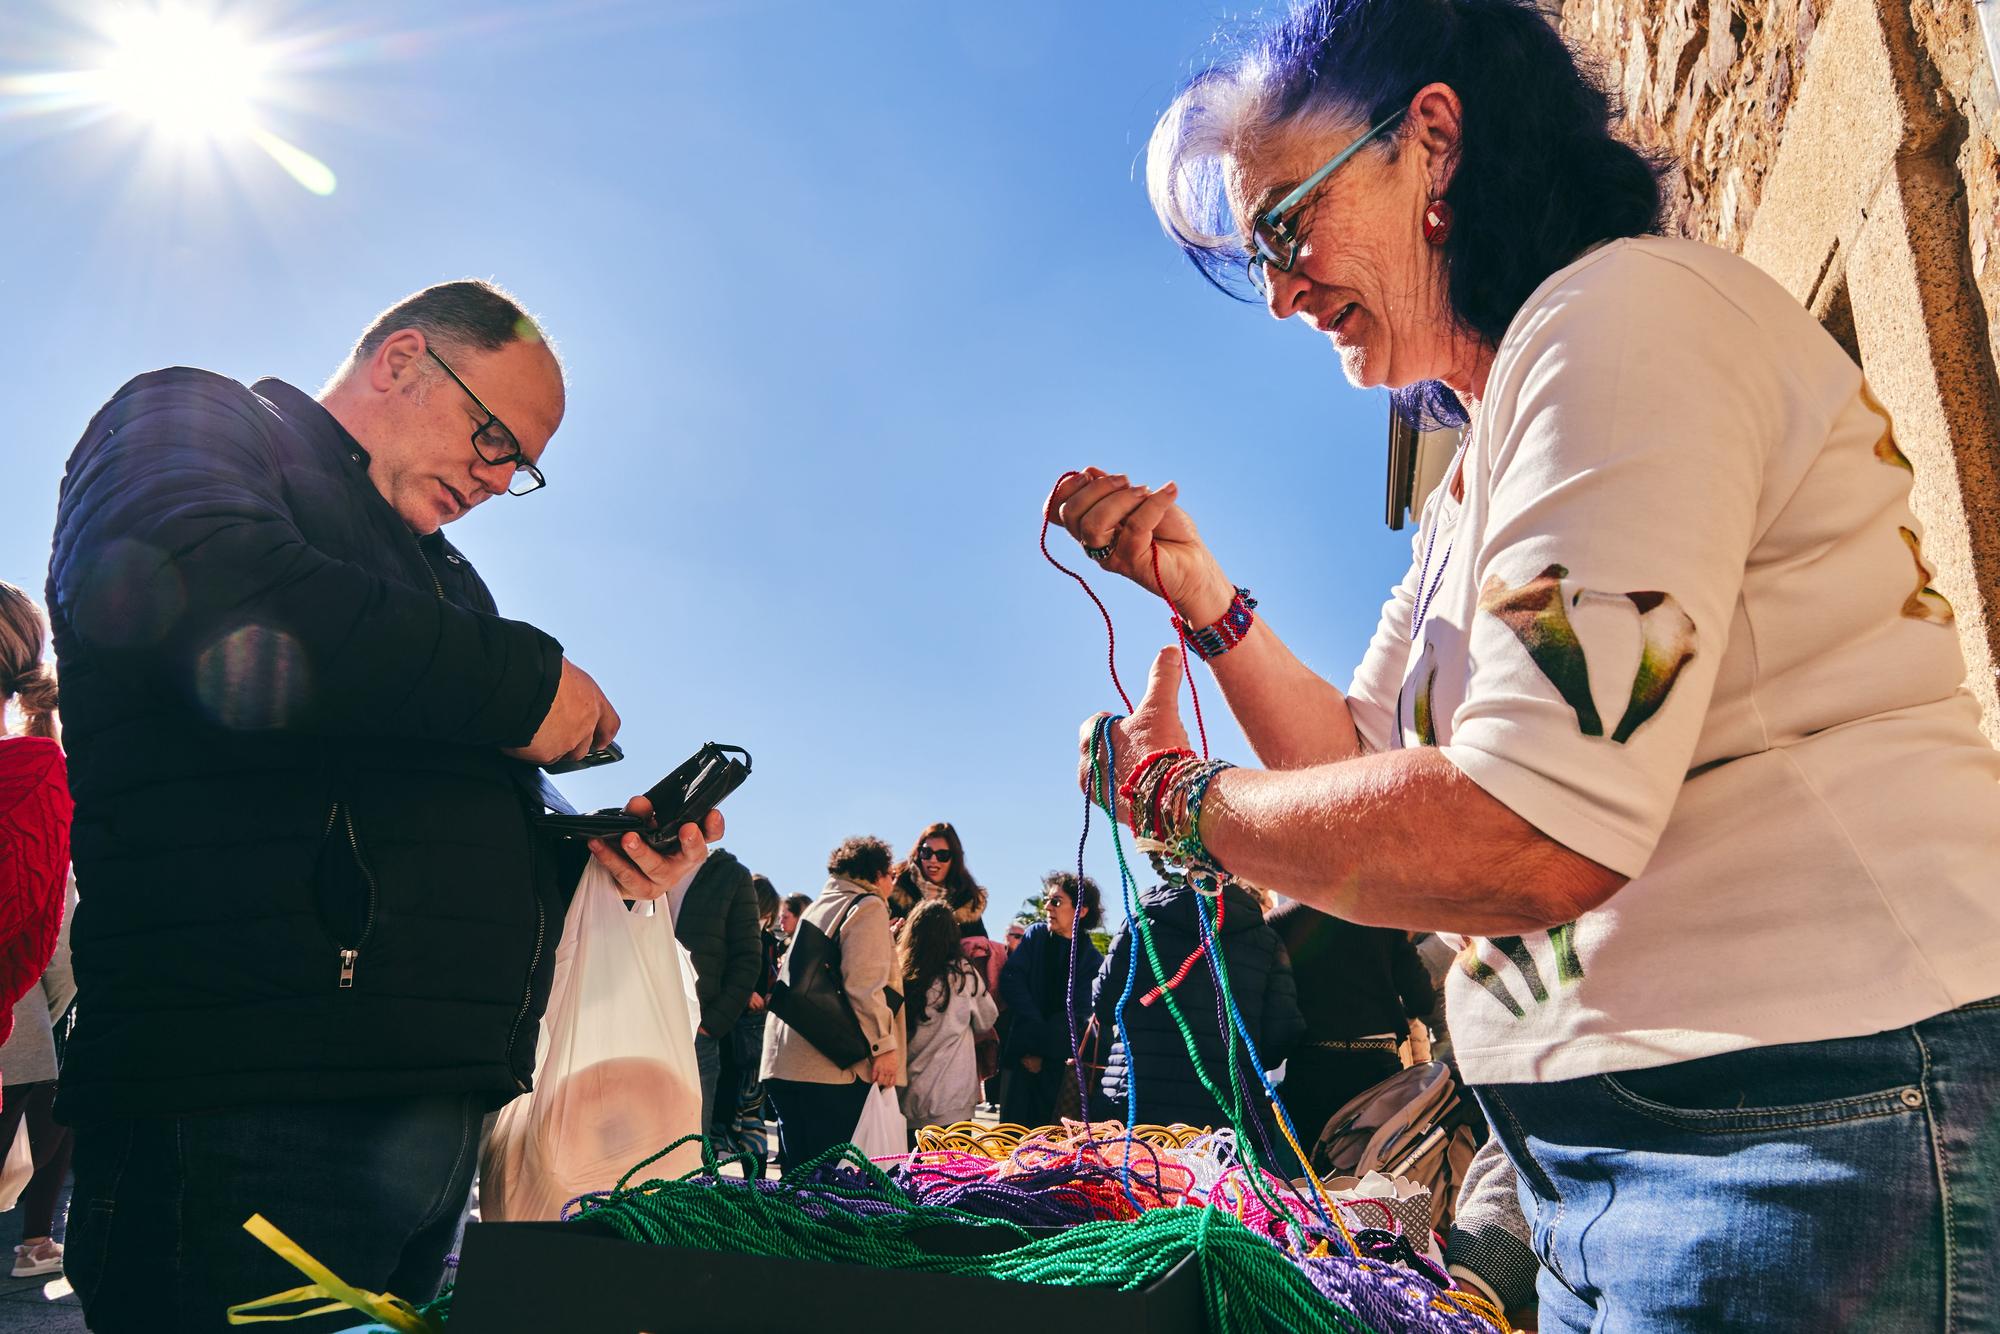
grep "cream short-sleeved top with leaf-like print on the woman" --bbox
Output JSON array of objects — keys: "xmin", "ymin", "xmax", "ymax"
[{"xmin": 1350, "ymin": 238, "xmax": 2000, "ymax": 1084}]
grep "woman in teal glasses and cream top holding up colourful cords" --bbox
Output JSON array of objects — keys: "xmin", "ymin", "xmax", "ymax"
[{"xmin": 1050, "ymin": 0, "xmax": 2000, "ymax": 1330}]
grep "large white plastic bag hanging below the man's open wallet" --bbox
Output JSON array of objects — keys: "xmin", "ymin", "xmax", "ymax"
[{"xmin": 480, "ymin": 862, "xmax": 702, "ymax": 1222}]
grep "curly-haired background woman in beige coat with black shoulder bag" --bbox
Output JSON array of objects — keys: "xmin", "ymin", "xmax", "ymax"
[{"xmin": 762, "ymin": 838, "xmax": 908, "ymax": 1170}]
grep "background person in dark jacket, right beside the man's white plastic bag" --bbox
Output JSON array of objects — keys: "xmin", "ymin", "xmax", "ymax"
[{"xmin": 674, "ymin": 848, "xmax": 764, "ymax": 1138}]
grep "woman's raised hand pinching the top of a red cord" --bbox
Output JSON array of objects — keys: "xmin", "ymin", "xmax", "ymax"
[{"xmin": 1046, "ymin": 468, "xmax": 1236, "ymax": 626}]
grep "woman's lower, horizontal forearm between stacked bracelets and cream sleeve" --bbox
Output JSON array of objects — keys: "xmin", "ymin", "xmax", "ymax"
[{"xmin": 1202, "ymin": 748, "xmax": 1624, "ymax": 936}]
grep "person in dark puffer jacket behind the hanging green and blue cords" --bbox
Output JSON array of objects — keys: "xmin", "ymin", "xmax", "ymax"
[{"xmin": 1092, "ymin": 884, "xmax": 1306, "ymax": 1170}]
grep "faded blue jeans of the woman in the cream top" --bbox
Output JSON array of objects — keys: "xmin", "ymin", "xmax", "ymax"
[{"xmin": 1476, "ymin": 998, "xmax": 2000, "ymax": 1334}]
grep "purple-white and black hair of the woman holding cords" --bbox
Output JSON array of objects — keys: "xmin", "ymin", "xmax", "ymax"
[{"xmin": 1146, "ymin": 0, "xmax": 1662, "ymax": 426}]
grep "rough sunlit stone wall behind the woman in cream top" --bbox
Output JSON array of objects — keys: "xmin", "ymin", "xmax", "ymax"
[{"xmin": 1546, "ymin": 0, "xmax": 2000, "ymax": 742}]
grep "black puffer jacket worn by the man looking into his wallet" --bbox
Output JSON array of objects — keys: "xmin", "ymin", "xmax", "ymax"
[{"xmin": 48, "ymin": 368, "xmax": 564, "ymax": 1122}]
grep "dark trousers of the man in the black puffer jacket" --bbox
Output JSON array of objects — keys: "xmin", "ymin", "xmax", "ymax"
[{"xmin": 64, "ymin": 1094, "xmax": 492, "ymax": 1334}]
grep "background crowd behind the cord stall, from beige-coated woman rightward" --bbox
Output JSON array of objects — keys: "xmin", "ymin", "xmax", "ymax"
[{"xmin": 752, "ymin": 824, "xmax": 1442, "ymax": 1172}]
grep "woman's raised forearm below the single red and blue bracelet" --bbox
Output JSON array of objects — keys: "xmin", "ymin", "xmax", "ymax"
[{"xmin": 1210, "ymin": 618, "xmax": 1362, "ymax": 770}]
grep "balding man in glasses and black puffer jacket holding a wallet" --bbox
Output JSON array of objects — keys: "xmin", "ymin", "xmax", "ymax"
[{"xmin": 48, "ymin": 282, "xmax": 720, "ymax": 1332}]
